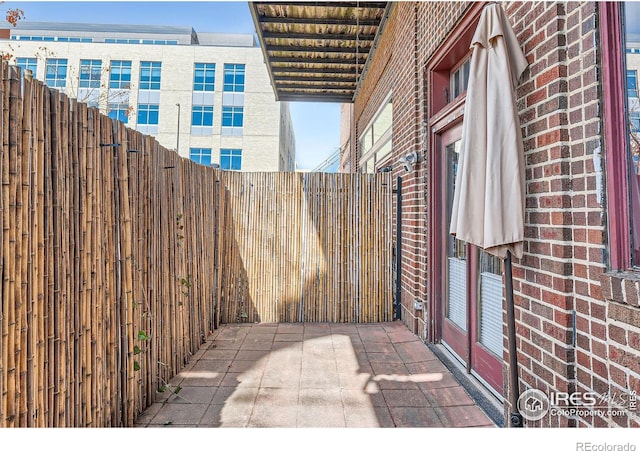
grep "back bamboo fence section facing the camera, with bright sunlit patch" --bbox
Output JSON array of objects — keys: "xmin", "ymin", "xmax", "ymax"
[{"xmin": 220, "ymin": 173, "xmax": 393, "ymax": 323}]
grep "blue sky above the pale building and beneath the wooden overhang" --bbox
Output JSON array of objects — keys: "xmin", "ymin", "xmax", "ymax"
[{"xmin": 0, "ymin": 1, "xmax": 340, "ymax": 169}]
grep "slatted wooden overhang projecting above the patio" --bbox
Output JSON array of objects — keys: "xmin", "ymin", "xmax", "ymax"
[{"xmin": 249, "ymin": 1, "xmax": 391, "ymax": 103}]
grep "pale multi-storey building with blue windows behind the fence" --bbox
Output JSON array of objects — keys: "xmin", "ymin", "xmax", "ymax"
[{"xmin": 0, "ymin": 21, "xmax": 295, "ymax": 171}]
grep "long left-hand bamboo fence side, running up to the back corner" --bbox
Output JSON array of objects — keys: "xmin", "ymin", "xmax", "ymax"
[{"xmin": 0, "ymin": 63, "xmax": 224, "ymax": 427}]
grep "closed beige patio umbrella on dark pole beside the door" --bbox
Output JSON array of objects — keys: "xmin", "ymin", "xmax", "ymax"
[{"xmin": 449, "ymin": 4, "xmax": 528, "ymax": 426}]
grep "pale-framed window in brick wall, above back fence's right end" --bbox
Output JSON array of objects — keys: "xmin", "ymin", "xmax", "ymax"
[{"xmin": 360, "ymin": 98, "xmax": 393, "ymax": 173}]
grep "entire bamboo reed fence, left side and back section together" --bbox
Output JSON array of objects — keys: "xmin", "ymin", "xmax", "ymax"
[{"xmin": 0, "ymin": 62, "xmax": 392, "ymax": 427}]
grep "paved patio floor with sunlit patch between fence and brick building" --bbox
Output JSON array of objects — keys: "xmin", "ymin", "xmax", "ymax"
[{"xmin": 136, "ymin": 322, "xmax": 495, "ymax": 428}]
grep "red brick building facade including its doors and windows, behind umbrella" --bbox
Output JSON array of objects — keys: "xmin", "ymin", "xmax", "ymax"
[{"xmin": 342, "ymin": 2, "xmax": 640, "ymax": 427}]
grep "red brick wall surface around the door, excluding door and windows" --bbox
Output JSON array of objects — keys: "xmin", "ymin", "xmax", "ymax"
[{"xmin": 352, "ymin": 2, "xmax": 640, "ymax": 426}]
